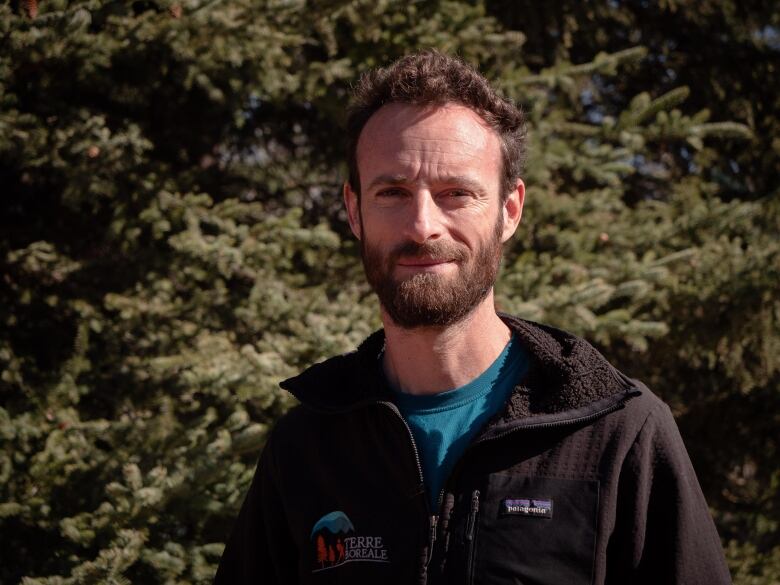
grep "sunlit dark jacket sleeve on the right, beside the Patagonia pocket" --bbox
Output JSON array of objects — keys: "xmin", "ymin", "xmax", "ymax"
[{"xmin": 607, "ymin": 403, "xmax": 731, "ymax": 585}]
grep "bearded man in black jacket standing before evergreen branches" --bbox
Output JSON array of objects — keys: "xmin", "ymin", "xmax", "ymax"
[{"xmin": 215, "ymin": 51, "xmax": 730, "ymax": 585}]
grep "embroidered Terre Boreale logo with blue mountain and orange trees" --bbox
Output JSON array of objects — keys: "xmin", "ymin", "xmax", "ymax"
[{"xmin": 311, "ymin": 510, "xmax": 390, "ymax": 573}]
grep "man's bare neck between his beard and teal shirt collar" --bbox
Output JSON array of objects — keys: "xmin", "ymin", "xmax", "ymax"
[{"xmin": 382, "ymin": 291, "xmax": 511, "ymax": 394}]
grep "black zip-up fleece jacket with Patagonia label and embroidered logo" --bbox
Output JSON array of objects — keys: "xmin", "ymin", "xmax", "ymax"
[{"xmin": 215, "ymin": 315, "xmax": 731, "ymax": 585}]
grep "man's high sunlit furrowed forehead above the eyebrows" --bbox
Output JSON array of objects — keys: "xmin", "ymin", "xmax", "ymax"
[{"xmin": 357, "ymin": 104, "xmax": 501, "ymax": 183}]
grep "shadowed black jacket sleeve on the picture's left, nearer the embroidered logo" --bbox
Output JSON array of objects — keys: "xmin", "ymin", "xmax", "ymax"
[{"xmin": 214, "ymin": 433, "xmax": 298, "ymax": 585}]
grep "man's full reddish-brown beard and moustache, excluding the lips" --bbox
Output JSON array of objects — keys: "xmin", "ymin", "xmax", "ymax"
[{"xmin": 360, "ymin": 214, "xmax": 503, "ymax": 329}]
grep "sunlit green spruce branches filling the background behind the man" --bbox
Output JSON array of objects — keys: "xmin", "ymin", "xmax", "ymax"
[{"xmin": 0, "ymin": 0, "xmax": 780, "ymax": 585}]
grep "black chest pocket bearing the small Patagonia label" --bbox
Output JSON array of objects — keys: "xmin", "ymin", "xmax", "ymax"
[{"xmin": 471, "ymin": 473, "xmax": 599, "ymax": 585}]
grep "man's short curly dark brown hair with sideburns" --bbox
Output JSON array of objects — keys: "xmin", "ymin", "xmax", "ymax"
[{"xmin": 347, "ymin": 49, "xmax": 526, "ymax": 200}]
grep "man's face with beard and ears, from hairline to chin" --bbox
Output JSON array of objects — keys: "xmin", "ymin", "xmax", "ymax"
[{"xmin": 345, "ymin": 104, "xmax": 522, "ymax": 328}]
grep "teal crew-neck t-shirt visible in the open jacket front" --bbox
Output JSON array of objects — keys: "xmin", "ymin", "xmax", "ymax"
[{"xmin": 395, "ymin": 335, "xmax": 528, "ymax": 511}]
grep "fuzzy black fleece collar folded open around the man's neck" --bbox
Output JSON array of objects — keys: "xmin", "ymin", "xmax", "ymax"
[{"xmin": 281, "ymin": 314, "xmax": 637, "ymax": 420}]
